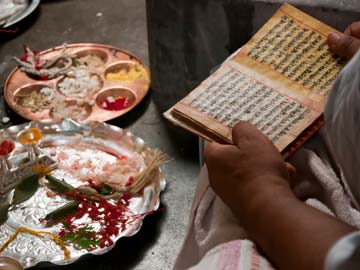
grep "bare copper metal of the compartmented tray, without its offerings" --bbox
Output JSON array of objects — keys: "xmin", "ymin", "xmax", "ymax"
[{"xmin": 4, "ymin": 43, "xmax": 150, "ymax": 122}]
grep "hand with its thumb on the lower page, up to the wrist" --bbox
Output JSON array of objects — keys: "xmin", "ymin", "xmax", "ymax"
[{"xmin": 204, "ymin": 122, "xmax": 294, "ymax": 210}]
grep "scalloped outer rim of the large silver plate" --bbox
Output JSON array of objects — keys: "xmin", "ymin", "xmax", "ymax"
[{"xmin": 0, "ymin": 119, "xmax": 166, "ymax": 269}]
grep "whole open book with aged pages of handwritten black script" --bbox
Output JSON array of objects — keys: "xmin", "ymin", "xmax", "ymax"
[{"xmin": 164, "ymin": 4, "xmax": 346, "ymax": 156}]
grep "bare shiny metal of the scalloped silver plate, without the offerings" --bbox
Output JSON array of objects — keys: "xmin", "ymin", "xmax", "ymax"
[{"xmin": 0, "ymin": 120, "xmax": 166, "ymax": 268}]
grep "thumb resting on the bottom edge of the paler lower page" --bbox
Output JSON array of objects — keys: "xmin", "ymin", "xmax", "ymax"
[{"xmin": 231, "ymin": 121, "xmax": 268, "ymax": 147}]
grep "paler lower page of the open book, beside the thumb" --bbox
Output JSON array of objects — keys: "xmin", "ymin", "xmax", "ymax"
[{"xmin": 173, "ymin": 66, "xmax": 321, "ymax": 151}]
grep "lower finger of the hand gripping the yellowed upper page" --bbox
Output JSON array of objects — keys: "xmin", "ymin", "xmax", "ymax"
[{"xmin": 328, "ymin": 32, "xmax": 360, "ymax": 58}]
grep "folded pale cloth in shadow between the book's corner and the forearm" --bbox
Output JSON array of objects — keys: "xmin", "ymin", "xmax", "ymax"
[{"xmin": 289, "ymin": 129, "xmax": 360, "ymax": 228}]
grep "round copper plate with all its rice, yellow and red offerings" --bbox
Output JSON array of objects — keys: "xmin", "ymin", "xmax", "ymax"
[{"xmin": 4, "ymin": 44, "xmax": 150, "ymax": 121}]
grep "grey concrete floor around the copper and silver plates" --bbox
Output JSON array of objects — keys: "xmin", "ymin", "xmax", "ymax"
[{"xmin": 0, "ymin": 0, "xmax": 198, "ymax": 270}]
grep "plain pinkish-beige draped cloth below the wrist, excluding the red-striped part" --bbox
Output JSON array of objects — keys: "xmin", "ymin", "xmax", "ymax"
[{"xmin": 174, "ymin": 166, "xmax": 247, "ymax": 270}]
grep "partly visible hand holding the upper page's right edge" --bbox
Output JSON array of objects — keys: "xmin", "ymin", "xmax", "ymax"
[{"xmin": 327, "ymin": 22, "xmax": 360, "ymax": 59}]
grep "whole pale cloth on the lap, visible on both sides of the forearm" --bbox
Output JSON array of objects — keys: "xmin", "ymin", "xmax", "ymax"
[{"xmin": 174, "ymin": 130, "xmax": 360, "ymax": 270}]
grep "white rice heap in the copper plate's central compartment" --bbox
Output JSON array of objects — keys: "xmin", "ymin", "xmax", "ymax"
[{"xmin": 58, "ymin": 69, "xmax": 101, "ymax": 98}]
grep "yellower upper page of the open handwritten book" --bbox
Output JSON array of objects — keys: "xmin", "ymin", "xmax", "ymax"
[{"xmin": 233, "ymin": 4, "xmax": 346, "ymax": 97}]
